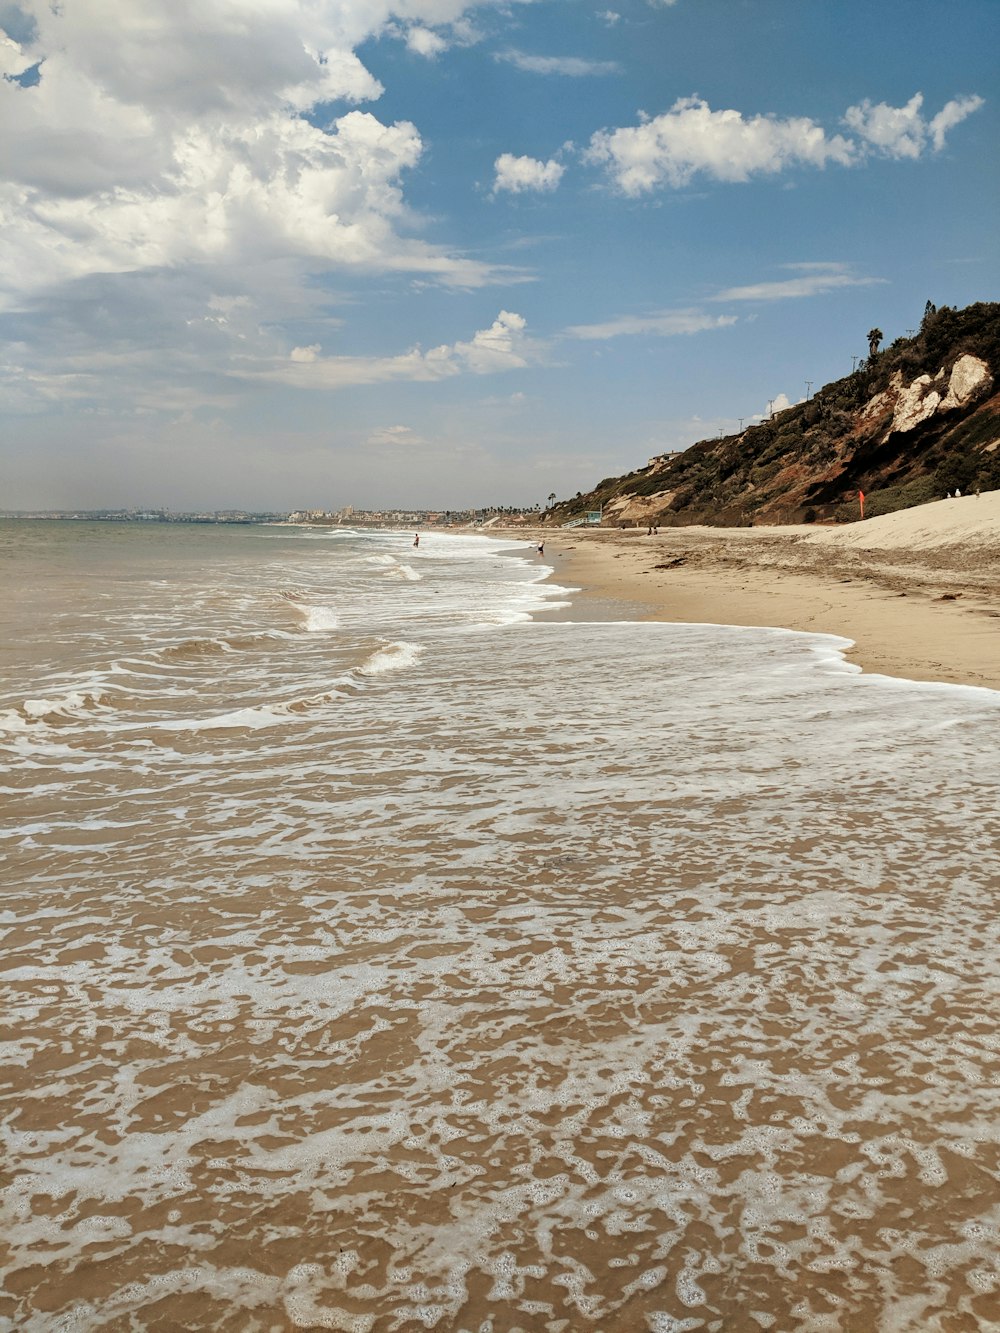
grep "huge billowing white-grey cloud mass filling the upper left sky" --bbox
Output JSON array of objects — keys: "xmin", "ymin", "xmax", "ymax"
[{"xmin": 0, "ymin": 0, "xmax": 528, "ymax": 305}]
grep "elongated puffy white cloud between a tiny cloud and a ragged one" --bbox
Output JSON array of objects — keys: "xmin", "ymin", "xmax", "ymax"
[{"xmin": 585, "ymin": 97, "xmax": 853, "ymax": 196}]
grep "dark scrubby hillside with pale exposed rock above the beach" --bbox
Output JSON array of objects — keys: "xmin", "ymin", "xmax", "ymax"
[{"xmin": 545, "ymin": 301, "xmax": 1000, "ymax": 528}]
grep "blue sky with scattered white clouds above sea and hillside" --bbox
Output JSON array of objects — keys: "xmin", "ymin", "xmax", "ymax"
[{"xmin": 0, "ymin": 0, "xmax": 1000, "ymax": 511}]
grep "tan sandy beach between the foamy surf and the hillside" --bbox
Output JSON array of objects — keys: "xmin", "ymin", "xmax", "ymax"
[{"xmin": 533, "ymin": 491, "xmax": 1000, "ymax": 689}]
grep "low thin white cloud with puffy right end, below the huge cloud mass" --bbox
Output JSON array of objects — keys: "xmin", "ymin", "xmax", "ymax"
[{"xmin": 258, "ymin": 311, "xmax": 543, "ymax": 389}]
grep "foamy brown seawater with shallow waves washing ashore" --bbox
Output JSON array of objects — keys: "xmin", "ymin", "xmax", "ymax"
[{"xmin": 0, "ymin": 521, "xmax": 1000, "ymax": 1333}]
